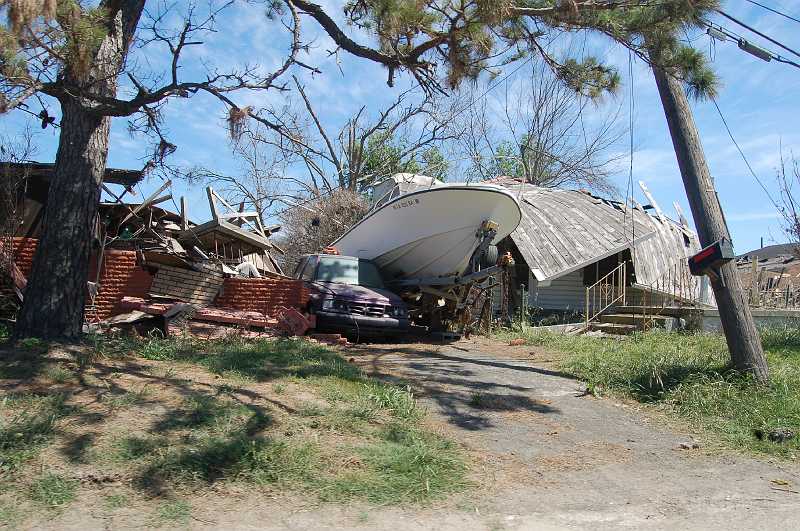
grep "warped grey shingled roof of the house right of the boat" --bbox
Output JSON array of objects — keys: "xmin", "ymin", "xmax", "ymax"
[{"xmin": 489, "ymin": 177, "xmax": 699, "ymax": 283}]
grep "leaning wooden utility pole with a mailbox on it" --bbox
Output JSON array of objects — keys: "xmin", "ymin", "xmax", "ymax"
[{"xmin": 650, "ymin": 55, "xmax": 769, "ymax": 383}]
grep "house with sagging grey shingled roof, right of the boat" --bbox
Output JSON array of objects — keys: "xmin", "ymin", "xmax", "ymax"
[{"xmin": 491, "ymin": 177, "xmax": 711, "ymax": 320}]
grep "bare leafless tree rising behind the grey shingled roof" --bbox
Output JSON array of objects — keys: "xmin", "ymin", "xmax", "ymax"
[{"xmin": 459, "ymin": 60, "xmax": 625, "ymax": 193}]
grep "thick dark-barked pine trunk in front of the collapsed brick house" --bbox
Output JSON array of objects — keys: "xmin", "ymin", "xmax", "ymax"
[{"xmin": 14, "ymin": 0, "xmax": 145, "ymax": 340}]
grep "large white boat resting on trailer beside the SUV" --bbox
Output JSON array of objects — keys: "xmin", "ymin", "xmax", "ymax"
[{"xmin": 333, "ymin": 174, "xmax": 522, "ymax": 280}]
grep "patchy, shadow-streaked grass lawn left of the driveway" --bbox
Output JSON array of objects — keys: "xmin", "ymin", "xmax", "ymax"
[{"xmin": 0, "ymin": 337, "xmax": 468, "ymax": 526}]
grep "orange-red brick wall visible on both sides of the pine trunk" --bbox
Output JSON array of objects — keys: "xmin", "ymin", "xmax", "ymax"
[{"xmin": 4, "ymin": 238, "xmax": 153, "ymax": 320}]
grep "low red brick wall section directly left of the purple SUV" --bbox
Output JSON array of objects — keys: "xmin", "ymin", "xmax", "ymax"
[{"xmin": 214, "ymin": 278, "xmax": 308, "ymax": 316}]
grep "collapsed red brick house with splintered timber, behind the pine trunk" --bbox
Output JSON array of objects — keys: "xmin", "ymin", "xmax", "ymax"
[{"xmin": 0, "ymin": 163, "xmax": 307, "ymax": 336}]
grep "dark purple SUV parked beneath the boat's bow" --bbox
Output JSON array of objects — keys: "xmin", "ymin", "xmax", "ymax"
[{"xmin": 294, "ymin": 254, "xmax": 409, "ymax": 336}]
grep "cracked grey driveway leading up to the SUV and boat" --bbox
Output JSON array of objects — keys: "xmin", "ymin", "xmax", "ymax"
[{"xmin": 332, "ymin": 339, "xmax": 800, "ymax": 530}]
